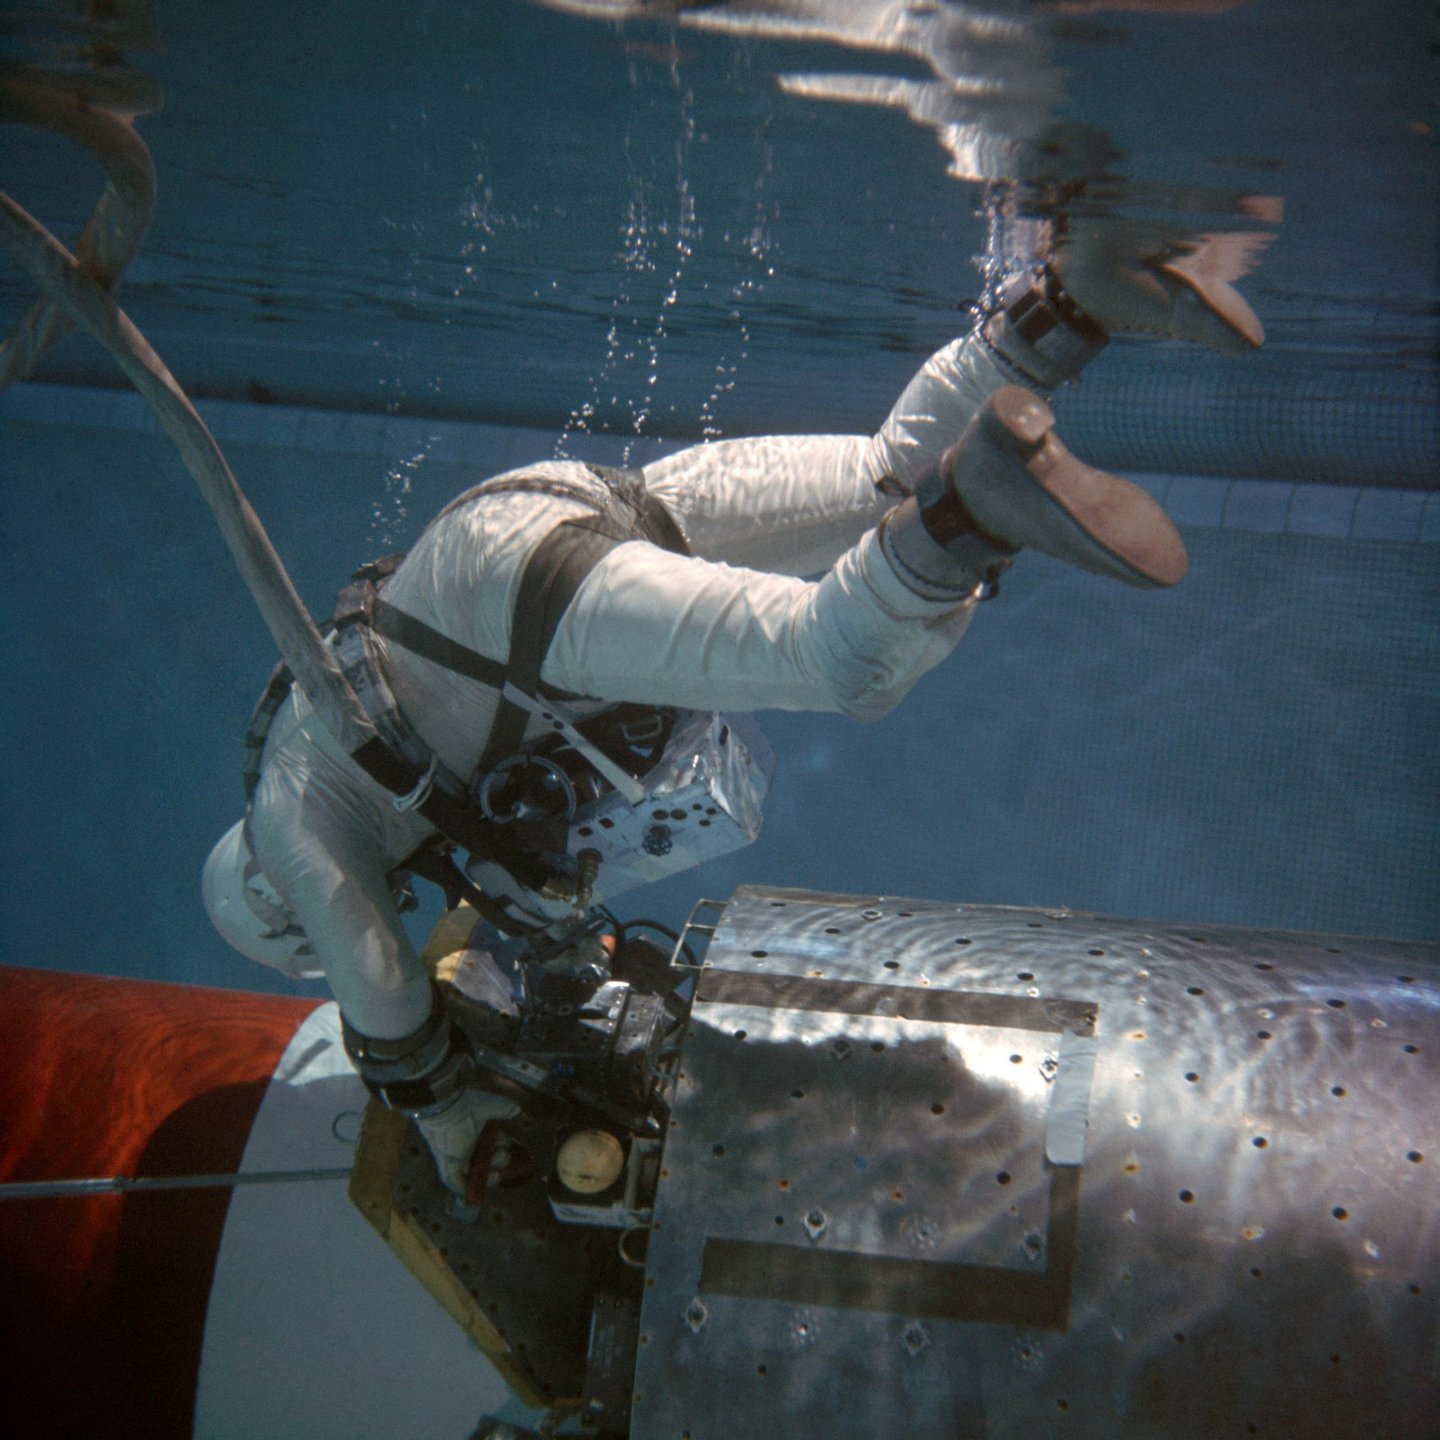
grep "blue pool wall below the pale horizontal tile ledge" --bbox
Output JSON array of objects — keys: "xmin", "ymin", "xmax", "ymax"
[{"xmin": 0, "ymin": 384, "xmax": 1440, "ymax": 991}]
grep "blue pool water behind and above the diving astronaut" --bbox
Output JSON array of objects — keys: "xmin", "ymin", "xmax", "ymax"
[{"xmin": 0, "ymin": 3, "xmax": 1440, "ymax": 988}]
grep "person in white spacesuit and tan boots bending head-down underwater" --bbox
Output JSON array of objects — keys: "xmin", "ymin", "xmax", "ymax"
[{"xmin": 204, "ymin": 238, "xmax": 1263, "ymax": 1194}]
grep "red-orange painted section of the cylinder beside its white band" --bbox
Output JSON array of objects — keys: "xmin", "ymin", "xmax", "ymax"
[{"xmin": 0, "ymin": 968, "xmax": 317, "ymax": 1440}]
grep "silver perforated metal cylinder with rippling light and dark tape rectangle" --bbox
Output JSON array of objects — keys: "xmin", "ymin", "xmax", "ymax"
[{"xmin": 632, "ymin": 887, "xmax": 1440, "ymax": 1440}]
